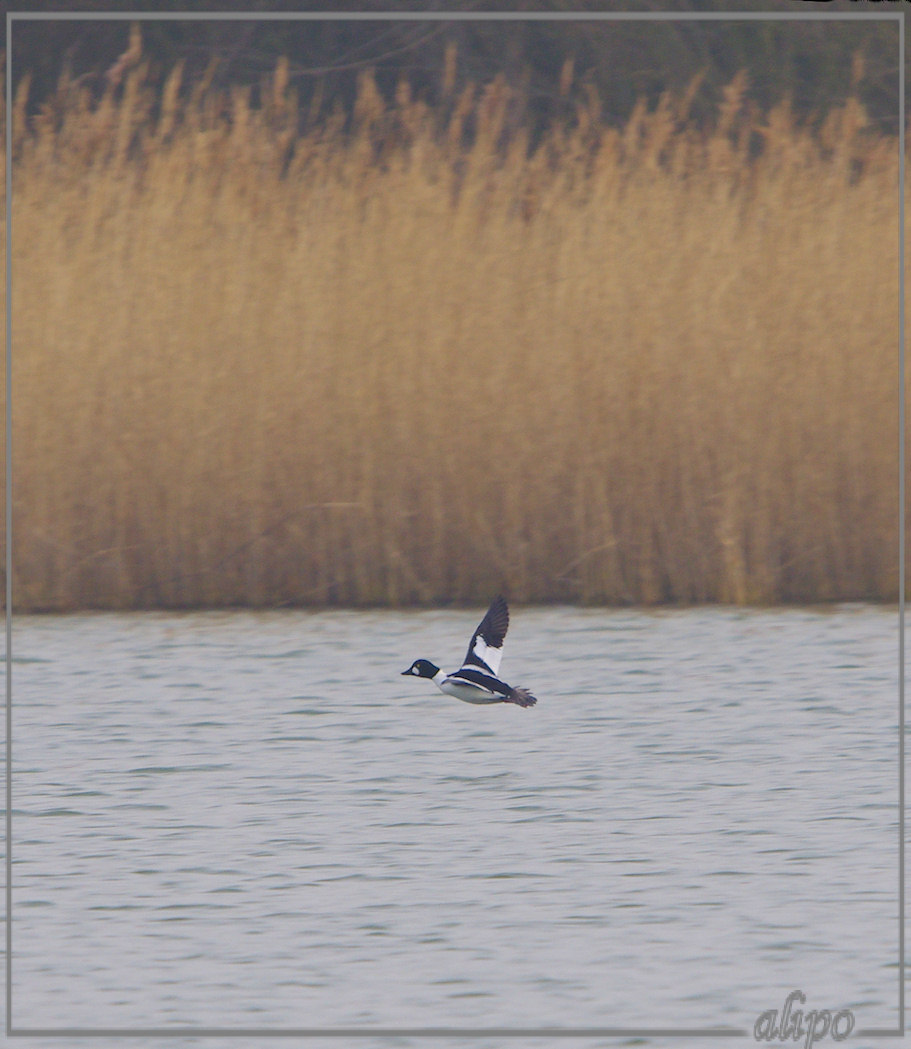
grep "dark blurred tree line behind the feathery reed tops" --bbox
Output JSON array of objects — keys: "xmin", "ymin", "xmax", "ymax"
[{"xmin": 0, "ymin": 0, "xmax": 898, "ymax": 137}]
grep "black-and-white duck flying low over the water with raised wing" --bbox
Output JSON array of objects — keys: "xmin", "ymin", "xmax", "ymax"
[{"xmin": 402, "ymin": 596, "xmax": 537, "ymax": 707}]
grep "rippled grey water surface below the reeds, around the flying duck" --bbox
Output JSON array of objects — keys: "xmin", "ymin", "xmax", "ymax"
[{"xmin": 5, "ymin": 607, "xmax": 898, "ymax": 1045}]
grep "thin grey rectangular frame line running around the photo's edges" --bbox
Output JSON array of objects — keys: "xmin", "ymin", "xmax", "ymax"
[{"xmin": 5, "ymin": 9, "xmax": 905, "ymax": 1039}]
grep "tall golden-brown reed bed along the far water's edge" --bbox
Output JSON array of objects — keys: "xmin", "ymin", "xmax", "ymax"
[{"xmin": 5, "ymin": 64, "xmax": 898, "ymax": 611}]
